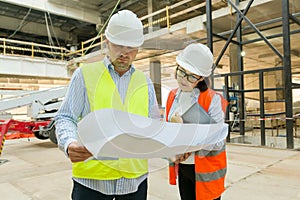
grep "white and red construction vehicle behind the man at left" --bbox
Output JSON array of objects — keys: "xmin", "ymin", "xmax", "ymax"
[{"xmin": 0, "ymin": 87, "xmax": 67, "ymax": 146}]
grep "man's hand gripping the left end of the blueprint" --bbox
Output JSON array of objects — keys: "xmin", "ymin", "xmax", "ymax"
[{"xmin": 68, "ymin": 142, "xmax": 93, "ymax": 162}]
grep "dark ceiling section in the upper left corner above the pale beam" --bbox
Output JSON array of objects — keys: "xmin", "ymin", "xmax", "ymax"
[{"xmin": 0, "ymin": 1, "xmax": 97, "ymax": 47}]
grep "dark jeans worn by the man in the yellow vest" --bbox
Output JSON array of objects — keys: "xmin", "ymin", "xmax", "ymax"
[{"xmin": 72, "ymin": 179, "xmax": 148, "ymax": 200}]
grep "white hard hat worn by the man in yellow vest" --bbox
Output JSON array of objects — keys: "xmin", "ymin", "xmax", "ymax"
[{"xmin": 105, "ymin": 10, "xmax": 144, "ymax": 47}]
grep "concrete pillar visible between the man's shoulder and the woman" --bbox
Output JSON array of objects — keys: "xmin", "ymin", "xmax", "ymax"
[{"xmin": 150, "ymin": 60, "xmax": 161, "ymax": 105}]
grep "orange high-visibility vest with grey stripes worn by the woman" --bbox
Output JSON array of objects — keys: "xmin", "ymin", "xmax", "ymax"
[{"xmin": 166, "ymin": 89, "xmax": 228, "ymax": 200}]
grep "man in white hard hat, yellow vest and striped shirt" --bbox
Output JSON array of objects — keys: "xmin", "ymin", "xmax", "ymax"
[{"xmin": 55, "ymin": 10, "xmax": 159, "ymax": 200}]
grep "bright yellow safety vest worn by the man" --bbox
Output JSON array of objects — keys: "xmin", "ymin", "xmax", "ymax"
[{"xmin": 73, "ymin": 62, "xmax": 149, "ymax": 180}]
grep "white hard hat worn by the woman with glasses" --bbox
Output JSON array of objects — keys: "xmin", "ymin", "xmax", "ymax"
[{"xmin": 176, "ymin": 43, "xmax": 214, "ymax": 77}]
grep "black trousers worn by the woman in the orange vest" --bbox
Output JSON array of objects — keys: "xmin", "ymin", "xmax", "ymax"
[{"xmin": 178, "ymin": 164, "xmax": 221, "ymax": 200}]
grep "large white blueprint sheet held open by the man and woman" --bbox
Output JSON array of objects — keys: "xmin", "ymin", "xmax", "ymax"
[{"xmin": 78, "ymin": 109, "xmax": 228, "ymax": 159}]
